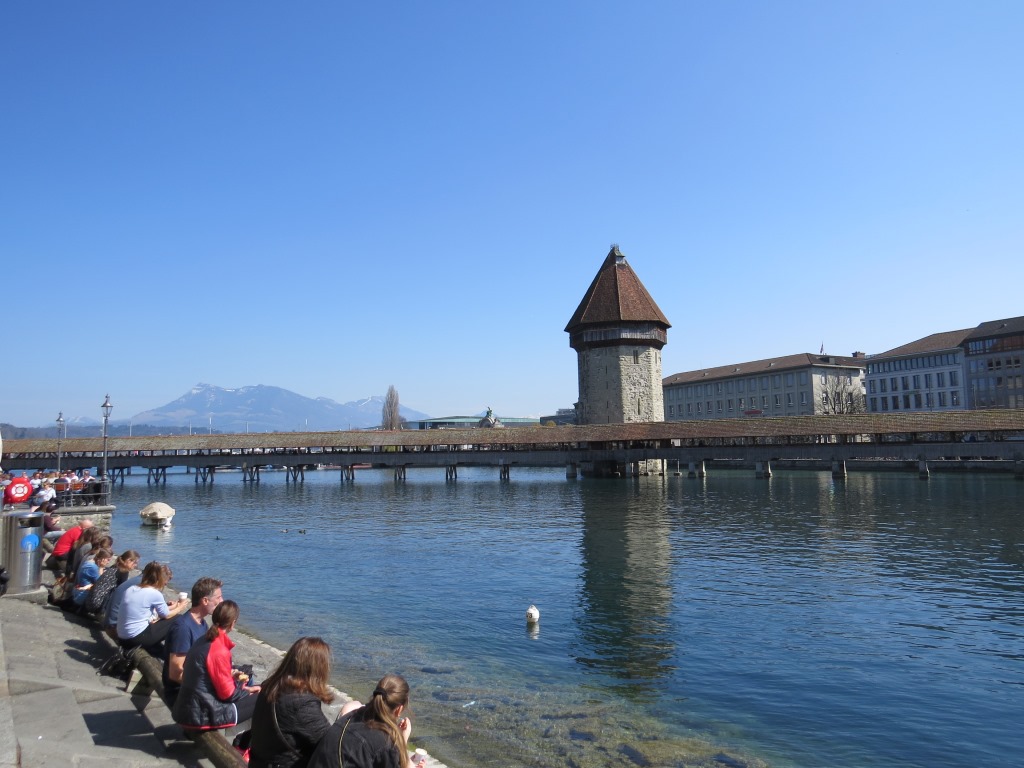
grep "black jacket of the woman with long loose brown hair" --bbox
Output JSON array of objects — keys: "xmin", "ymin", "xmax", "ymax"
[{"xmin": 249, "ymin": 692, "xmax": 331, "ymax": 768}]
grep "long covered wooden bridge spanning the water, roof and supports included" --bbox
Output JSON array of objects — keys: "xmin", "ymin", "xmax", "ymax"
[{"xmin": 8, "ymin": 410, "xmax": 1024, "ymax": 482}]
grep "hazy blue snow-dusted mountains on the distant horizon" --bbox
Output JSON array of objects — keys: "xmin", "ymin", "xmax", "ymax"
[{"xmin": 130, "ymin": 384, "xmax": 428, "ymax": 432}]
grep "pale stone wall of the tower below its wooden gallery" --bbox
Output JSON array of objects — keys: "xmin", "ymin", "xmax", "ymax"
[{"xmin": 579, "ymin": 344, "xmax": 665, "ymax": 424}]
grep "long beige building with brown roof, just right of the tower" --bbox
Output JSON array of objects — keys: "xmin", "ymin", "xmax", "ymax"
[{"xmin": 663, "ymin": 352, "xmax": 864, "ymax": 421}]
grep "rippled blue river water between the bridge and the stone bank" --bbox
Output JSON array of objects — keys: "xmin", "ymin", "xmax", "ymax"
[{"xmin": 105, "ymin": 469, "xmax": 1024, "ymax": 768}]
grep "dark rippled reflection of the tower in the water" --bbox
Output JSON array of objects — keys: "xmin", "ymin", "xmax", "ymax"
[{"xmin": 575, "ymin": 482, "xmax": 676, "ymax": 696}]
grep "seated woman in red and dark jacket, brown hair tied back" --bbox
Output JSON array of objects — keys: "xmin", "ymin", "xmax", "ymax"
[{"xmin": 171, "ymin": 600, "xmax": 260, "ymax": 730}]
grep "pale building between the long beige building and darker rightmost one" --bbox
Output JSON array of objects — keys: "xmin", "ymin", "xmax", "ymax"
[{"xmin": 865, "ymin": 329, "xmax": 972, "ymax": 413}]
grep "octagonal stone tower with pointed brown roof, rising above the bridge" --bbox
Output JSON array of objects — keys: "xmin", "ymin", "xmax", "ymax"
[{"xmin": 565, "ymin": 246, "xmax": 672, "ymax": 424}]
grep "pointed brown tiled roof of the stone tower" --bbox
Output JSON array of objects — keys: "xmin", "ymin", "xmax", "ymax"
[{"xmin": 565, "ymin": 246, "xmax": 672, "ymax": 334}]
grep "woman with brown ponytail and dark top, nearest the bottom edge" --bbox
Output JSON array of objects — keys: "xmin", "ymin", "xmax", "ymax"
[{"xmin": 308, "ymin": 675, "xmax": 413, "ymax": 768}]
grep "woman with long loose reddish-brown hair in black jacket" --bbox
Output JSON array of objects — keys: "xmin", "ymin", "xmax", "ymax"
[{"xmin": 249, "ymin": 637, "xmax": 334, "ymax": 768}]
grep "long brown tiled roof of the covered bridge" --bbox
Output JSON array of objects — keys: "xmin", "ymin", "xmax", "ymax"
[{"xmin": 3, "ymin": 410, "xmax": 1024, "ymax": 456}]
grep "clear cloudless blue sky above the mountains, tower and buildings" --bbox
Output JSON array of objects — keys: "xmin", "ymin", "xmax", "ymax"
[{"xmin": 0, "ymin": 0, "xmax": 1024, "ymax": 426}]
